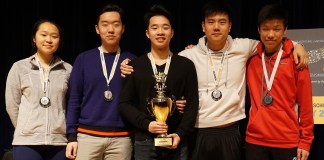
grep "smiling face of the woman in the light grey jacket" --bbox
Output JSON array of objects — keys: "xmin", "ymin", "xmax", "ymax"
[{"xmin": 33, "ymin": 22, "xmax": 60, "ymax": 56}]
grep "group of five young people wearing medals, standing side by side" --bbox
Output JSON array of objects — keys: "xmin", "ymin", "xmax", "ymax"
[{"xmin": 6, "ymin": 2, "xmax": 313, "ymax": 160}]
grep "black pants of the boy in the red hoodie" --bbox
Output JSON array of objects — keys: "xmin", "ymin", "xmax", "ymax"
[{"xmin": 245, "ymin": 143, "xmax": 297, "ymax": 160}]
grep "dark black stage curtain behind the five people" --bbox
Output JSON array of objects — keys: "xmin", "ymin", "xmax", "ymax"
[{"xmin": 0, "ymin": 0, "xmax": 324, "ymax": 160}]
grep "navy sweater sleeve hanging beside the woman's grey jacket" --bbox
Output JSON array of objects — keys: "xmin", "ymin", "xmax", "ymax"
[{"xmin": 66, "ymin": 56, "xmax": 83, "ymax": 142}]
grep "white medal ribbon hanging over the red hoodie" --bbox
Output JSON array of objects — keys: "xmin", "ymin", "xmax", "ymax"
[{"xmin": 262, "ymin": 46, "xmax": 283, "ymax": 91}]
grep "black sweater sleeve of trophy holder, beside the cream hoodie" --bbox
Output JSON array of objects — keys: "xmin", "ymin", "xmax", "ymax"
[{"xmin": 176, "ymin": 61, "xmax": 199, "ymax": 139}]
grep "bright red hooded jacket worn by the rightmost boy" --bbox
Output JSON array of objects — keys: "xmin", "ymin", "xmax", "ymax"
[{"xmin": 246, "ymin": 38, "xmax": 314, "ymax": 151}]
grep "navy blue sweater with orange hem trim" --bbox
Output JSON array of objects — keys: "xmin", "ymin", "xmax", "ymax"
[{"xmin": 66, "ymin": 48, "xmax": 135, "ymax": 141}]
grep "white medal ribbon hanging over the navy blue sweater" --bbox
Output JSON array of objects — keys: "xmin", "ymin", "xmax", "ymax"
[{"xmin": 98, "ymin": 46, "xmax": 120, "ymax": 87}]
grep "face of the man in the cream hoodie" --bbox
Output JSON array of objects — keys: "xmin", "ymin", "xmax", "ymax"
[{"xmin": 202, "ymin": 13, "xmax": 232, "ymax": 50}]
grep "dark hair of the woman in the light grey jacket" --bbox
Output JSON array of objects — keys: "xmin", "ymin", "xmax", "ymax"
[{"xmin": 31, "ymin": 19, "xmax": 63, "ymax": 54}]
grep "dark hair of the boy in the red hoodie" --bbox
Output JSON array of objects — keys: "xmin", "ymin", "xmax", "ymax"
[{"xmin": 258, "ymin": 4, "xmax": 288, "ymax": 27}]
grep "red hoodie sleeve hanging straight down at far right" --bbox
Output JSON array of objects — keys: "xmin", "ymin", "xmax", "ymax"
[{"xmin": 297, "ymin": 65, "xmax": 314, "ymax": 151}]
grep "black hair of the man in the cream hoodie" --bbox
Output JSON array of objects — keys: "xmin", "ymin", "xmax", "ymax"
[{"xmin": 201, "ymin": 1, "xmax": 233, "ymax": 22}]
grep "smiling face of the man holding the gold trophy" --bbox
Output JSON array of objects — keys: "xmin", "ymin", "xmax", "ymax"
[{"xmin": 146, "ymin": 16, "xmax": 173, "ymax": 49}]
